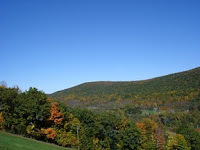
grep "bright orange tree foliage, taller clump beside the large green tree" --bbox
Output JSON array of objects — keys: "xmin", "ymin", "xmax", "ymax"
[{"xmin": 49, "ymin": 102, "xmax": 63, "ymax": 124}]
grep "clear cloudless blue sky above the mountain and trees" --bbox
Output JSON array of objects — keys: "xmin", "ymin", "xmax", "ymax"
[{"xmin": 0, "ymin": 0, "xmax": 200, "ymax": 93}]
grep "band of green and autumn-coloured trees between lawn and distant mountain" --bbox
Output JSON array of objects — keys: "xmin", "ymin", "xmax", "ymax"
[{"xmin": 0, "ymin": 86, "xmax": 200, "ymax": 150}]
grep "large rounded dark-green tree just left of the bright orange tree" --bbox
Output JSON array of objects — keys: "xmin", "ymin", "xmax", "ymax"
[{"xmin": 16, "ymin": 88, "xmax": 50, "ymax": 127}]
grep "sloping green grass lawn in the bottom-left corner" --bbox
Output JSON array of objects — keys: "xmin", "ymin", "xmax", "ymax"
[{"xmin": 0, "ymin": 131, "xmax": 72, "ymax": 150}]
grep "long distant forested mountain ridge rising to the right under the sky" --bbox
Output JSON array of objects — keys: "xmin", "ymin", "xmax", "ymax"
[{"xmin": 49, "ymin": 67, "xmax": 200, "ymax": 108}]
